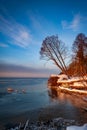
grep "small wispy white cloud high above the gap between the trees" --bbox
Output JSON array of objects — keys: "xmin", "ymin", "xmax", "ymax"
[{"xmin": 61, "ymin": 14, "xmax": 81, "ymax": 31}]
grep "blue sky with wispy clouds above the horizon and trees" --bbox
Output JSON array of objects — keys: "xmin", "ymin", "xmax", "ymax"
[{"xmin": 0, "ymin": 0, "xmax": 87, "ymax": 77}]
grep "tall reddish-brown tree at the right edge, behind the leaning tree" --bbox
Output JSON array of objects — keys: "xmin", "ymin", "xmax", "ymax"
[{"xmin": 69, "ymin": 33, "xmax": 87, "ymax": 76}]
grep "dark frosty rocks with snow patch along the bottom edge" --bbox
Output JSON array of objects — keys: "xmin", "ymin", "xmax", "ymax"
[{"xmin": 6, "ymin": 117, "xmax": 87, "ymax": 130}]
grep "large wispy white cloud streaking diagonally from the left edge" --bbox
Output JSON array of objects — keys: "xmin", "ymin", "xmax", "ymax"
[{"xmin": 0, "ymin": 11, "xmax": 32, "ymax": 47}]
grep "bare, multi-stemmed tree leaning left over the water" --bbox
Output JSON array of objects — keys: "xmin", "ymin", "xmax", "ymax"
[{"xmin": 40, "ymin": 35, "xmax": 67, "ymax": 74}]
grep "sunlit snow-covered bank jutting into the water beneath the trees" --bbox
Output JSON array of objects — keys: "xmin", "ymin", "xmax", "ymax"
[{"xmin": 48, "ymin": 74, "xmax": 87, "ymax": 95}]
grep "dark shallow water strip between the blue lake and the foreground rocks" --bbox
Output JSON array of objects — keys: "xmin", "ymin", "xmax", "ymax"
[{"xmin": 0, "ymin": 104, "xmax": 87, "ymax": 129}]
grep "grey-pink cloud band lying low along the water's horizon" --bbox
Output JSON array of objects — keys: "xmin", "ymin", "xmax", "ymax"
[{"xmin": 0, "ymin": 63, "xmax": 57, "ymax": 77}]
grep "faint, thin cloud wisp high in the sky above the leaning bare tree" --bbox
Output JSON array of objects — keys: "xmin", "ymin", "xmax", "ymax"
[{"xmin": 28, "ymin": 11, "xmax": 52, "ymax": 37}]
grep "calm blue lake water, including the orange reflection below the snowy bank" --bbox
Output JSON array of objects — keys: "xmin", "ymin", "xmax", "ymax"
[{"xmin": 0, "ymin": 78, "xmax": 87, "ymax": 127}]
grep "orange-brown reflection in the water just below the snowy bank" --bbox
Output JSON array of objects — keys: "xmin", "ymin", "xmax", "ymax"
[{"xmin": 48, "ymin": 88, "xmax": 87, "ymax": 109}]
